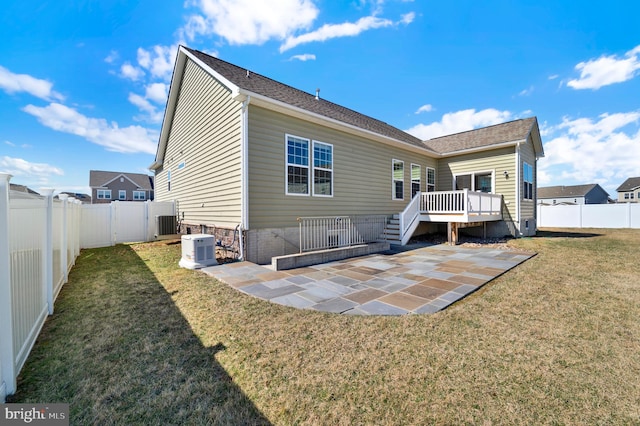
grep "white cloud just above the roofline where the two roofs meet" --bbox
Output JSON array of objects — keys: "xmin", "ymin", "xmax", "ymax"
[{"xmin": 406, "ymin": 108, "xmax": 513, "ymax": 140}]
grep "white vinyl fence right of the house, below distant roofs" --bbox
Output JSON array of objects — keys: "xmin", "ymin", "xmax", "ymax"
[{"xmin": 538, "ymin": 203, "xmax": 640, "ymax": 229}]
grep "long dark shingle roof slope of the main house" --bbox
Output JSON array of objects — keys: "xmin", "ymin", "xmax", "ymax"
[{"xmin": 185, "ymin": 47, "xmax": 427, "ymax": 148}]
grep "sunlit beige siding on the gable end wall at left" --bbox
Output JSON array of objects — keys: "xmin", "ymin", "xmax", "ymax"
[{"xmin": 155, "ymin": 60, "xmax": 241, "ymax": 227}]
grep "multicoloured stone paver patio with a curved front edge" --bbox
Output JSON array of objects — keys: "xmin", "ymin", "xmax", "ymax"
[{"xmin": 202, "ymin": 244, "xmax": 535, "ymax": 315}]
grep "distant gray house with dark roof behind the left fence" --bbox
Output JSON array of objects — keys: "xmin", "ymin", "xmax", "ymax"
[{"xmin": 89, "ymin": 170, "xmax": 153, "ymax": 204}]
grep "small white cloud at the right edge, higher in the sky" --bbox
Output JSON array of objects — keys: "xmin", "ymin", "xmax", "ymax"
[{"xmin": 567, "ymin": 45, "xmax": 640, "ymax": 90}]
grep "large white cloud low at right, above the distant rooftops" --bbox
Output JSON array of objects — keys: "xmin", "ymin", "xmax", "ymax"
[{"xmin": 539, "ymin": 111, "xmax": 640, "ymax": 189}]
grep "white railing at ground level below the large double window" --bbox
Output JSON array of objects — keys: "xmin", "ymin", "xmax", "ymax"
[{"xmin": 298, "ymin": 215, "xmax": 387, "ymax": 253}]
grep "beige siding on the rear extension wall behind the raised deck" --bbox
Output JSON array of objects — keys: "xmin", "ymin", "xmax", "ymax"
[{"xmin": 436, "ymin": 147, "xmax": 517, "ymax": 217}]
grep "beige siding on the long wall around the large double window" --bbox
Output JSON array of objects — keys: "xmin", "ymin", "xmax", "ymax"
[{"xmin": 249, "ymin": 105, "xmax": 436, "ymax": 229}]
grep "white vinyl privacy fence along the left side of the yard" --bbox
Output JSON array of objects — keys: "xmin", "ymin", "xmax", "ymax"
[{"xmin": 0, "ymin": 173, "xmax": 175, "ymax": 403}]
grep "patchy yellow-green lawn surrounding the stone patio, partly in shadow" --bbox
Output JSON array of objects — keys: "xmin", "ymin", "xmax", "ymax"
[{"xmin": 9, "ymin": 229, "xmax": 640, "ymax": 425}]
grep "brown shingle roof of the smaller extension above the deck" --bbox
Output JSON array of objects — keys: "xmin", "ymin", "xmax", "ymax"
[{"xmin": 424, "ymin": 117, "xmax": 537, "ymax": 154}]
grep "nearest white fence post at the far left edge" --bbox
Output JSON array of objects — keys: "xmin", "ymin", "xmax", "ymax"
[{"xmin": 0, "ymin": 173, "xmax": 17, "ymax": 402}]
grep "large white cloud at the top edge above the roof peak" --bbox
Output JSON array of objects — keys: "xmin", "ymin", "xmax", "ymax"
[{"xmin": 181, "ymin": 0, "xmax": 319, "ymax": 45}]
